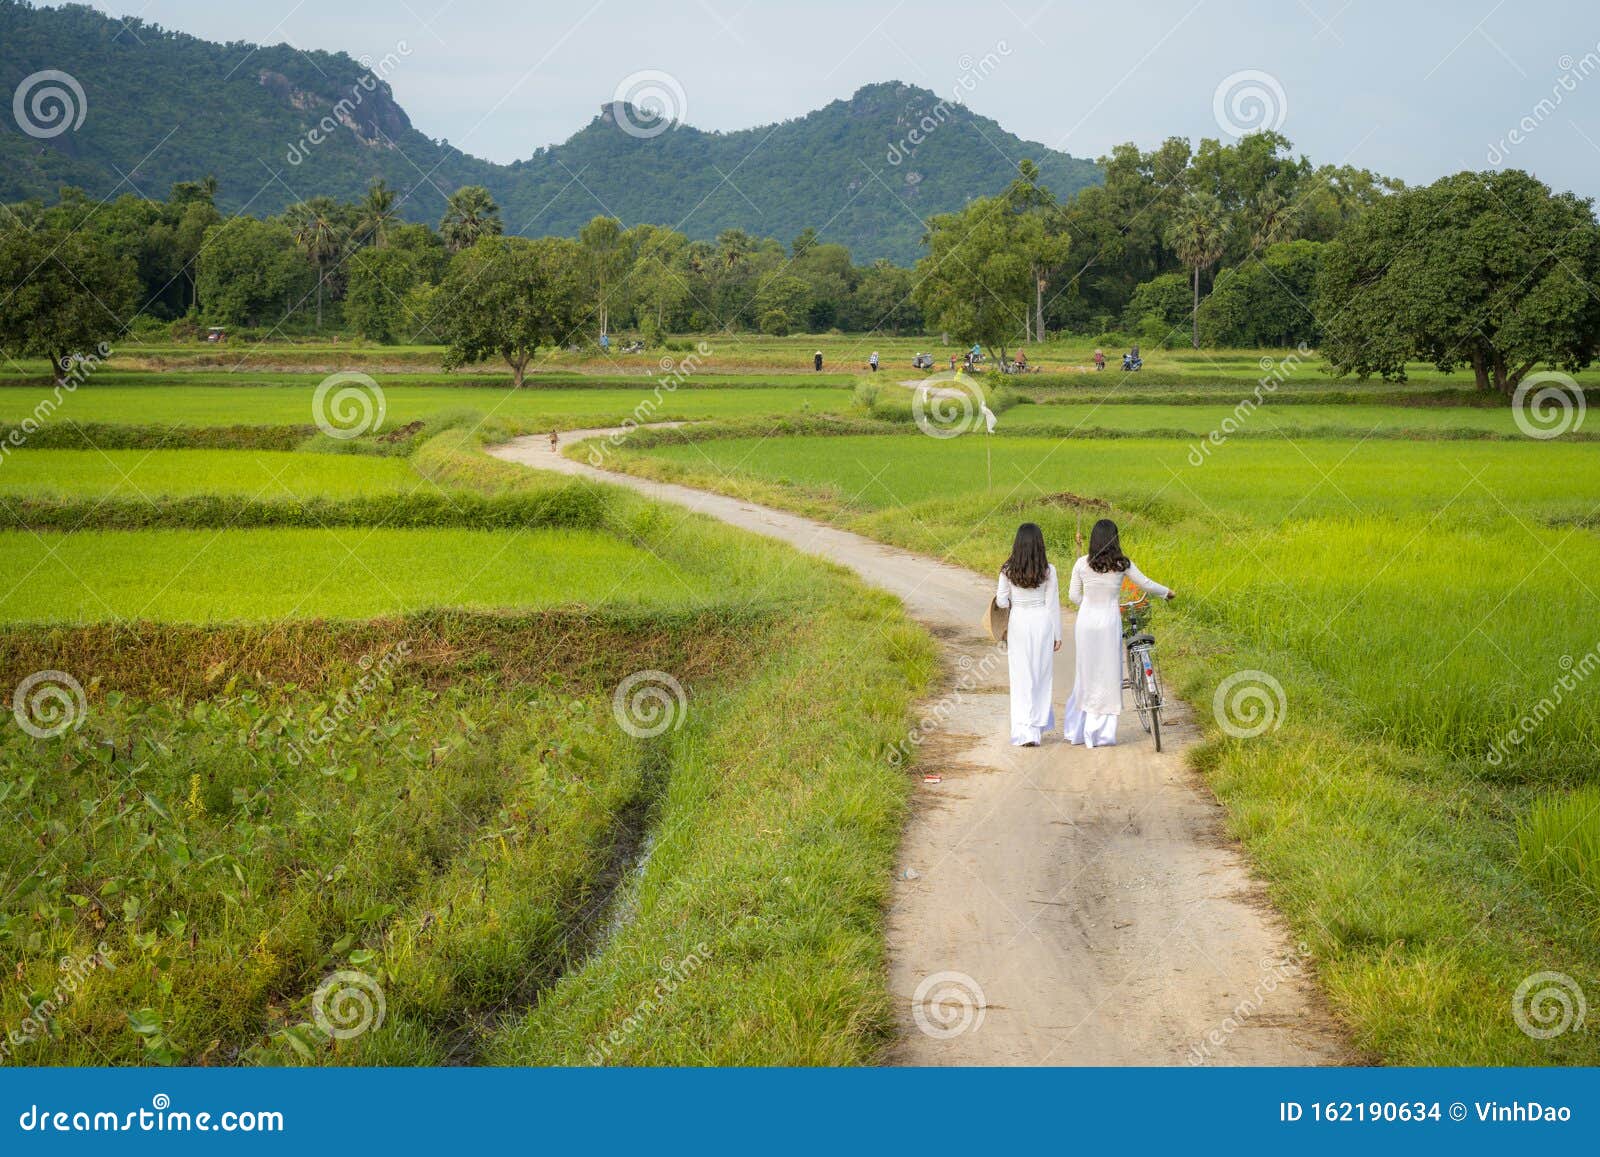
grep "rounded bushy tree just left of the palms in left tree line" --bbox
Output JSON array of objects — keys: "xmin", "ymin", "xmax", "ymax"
[{"xmin": 197, "ymin": 218, "xmax": 314, "ymax": 325}]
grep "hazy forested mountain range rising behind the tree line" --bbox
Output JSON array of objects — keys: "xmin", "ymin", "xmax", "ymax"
[{"xmin": 0, "ymin": 0, "xmax": 1101, "ymax": 262}]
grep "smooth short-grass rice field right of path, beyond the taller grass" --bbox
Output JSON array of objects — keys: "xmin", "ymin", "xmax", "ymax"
[{"xmin": 622, "ymin": 432, "xmax": 1600, "ymax": 526}]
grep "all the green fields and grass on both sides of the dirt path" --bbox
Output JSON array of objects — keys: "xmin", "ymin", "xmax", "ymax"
[{"xmin": 0, "ymin": 355, "xmax": 1600, "ymax": 1064}]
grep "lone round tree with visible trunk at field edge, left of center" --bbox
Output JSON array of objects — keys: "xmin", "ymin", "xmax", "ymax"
[{"xmin": 438, "ymin": 237, "xmax": 584, "ymax": 387}]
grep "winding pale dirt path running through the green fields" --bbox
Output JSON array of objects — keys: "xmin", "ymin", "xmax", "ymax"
[{"xmin": 491, "ymin": 430, "xmax": 1349, "ymax": 1064}]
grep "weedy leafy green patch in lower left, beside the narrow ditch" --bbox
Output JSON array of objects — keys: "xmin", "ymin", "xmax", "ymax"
[{"xmin": 0, "ymin": 668, "xmax": 642, "ymax": 1064}]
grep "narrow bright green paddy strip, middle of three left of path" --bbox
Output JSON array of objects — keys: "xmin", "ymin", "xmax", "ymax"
[{"xmin": 0, "ymin": 450, "xmax": 422, "ymax": 501}]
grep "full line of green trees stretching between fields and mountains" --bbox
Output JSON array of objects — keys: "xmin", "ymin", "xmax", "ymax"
[{"xmin": 0, "ymin": 133, "xmax": 1600, "ymax": 392}]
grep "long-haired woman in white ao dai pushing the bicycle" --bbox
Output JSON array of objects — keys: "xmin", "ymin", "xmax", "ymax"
[{"xmin": 1062, "ymin": 518, "xmax": 1173, "ymax": 747}]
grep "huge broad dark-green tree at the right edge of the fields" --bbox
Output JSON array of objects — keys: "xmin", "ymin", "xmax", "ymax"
[{"xmin": 1317, "ymin": 170, "xmax": 1600, "ymax": 394}]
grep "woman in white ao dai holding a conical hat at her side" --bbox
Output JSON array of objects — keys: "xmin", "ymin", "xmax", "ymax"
[{"xmin": 995, "ymin": 522, "xmax": 1056, "ymax": 747}]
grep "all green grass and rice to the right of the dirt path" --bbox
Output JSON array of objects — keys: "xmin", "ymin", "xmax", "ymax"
[{"xmin": 613, "ymin": 428, "xmax": 1600, "ymax": 1064}]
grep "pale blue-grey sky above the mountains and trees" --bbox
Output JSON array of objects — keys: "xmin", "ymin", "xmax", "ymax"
[{"xmin": 81, "ymin": 0, "xmax": 1600, "ymax": 195}]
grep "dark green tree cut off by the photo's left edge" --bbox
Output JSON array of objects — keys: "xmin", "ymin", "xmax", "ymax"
[{"xmin": 0, "ymin": 227, "xmax": 139, "ymax": 384}]
